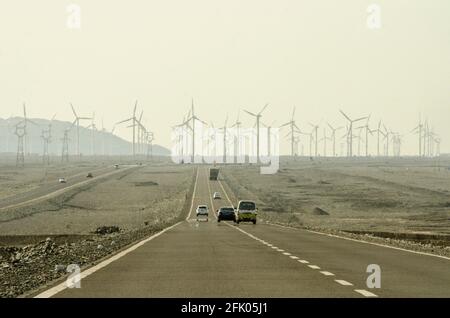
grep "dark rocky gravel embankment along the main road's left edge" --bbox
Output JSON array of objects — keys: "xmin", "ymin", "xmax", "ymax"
[{"xmin": 0, "ymin": 218, "xmax": 179, "ymax": 297}]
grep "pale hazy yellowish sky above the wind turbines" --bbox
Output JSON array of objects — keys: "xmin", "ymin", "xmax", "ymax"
[{"xmin": 0, "ymin": 0, "xmax": 450, "ymax": 153}]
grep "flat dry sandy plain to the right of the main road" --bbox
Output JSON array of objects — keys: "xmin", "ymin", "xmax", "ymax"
[{"xmin": 224, "ymin": 159, "xmax": 450, "ymax": 244}]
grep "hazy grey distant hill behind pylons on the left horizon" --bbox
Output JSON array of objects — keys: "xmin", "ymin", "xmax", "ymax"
[{"xmin": 0, "ymin": 117, "xmax": 170, "ymax": 156}]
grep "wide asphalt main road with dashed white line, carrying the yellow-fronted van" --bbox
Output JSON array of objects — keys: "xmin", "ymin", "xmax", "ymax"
[{"xmin": 38, "ymin": 168, "xmax": 450, "ymax": 297}]
